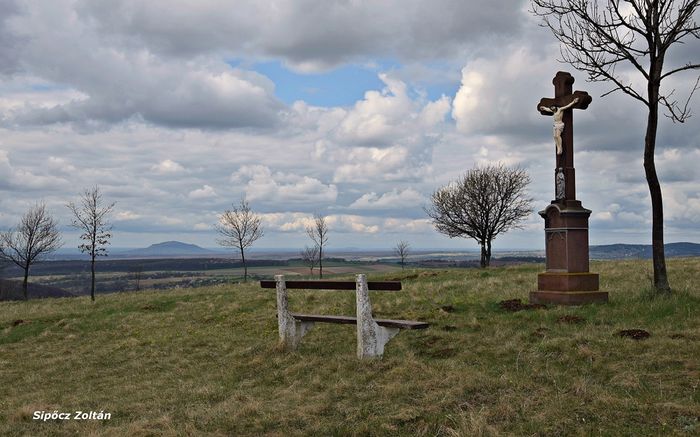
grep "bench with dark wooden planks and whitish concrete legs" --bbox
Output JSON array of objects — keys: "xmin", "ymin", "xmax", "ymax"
[{"xmin": 260, "ymin": 275, "xmax": 429, "ymax": 358}]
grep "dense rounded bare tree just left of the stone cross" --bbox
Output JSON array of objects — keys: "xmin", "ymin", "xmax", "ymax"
[{"xmin": 425, "ymin": 164, "xmax": 532, "ymax": 267}]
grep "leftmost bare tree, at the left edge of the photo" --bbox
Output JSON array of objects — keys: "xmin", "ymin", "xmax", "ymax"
[{"xmin": 0, "ymin": 203, "xmax": 62, "ymax": 299}]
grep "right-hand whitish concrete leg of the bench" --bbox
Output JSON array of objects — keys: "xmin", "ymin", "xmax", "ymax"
[{"xmin": 355, "ymin": 275, "xmax": 399, "ymax": 359}]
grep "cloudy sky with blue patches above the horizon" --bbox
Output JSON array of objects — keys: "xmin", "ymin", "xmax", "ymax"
[{"xmin": 0, "ymin": 0, "xmax": 700, "ymax": 250}]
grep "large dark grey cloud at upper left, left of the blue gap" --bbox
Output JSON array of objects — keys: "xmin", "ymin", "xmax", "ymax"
[{"xmin": 4, "ymin": 0, "xmax": 284, "ymax": 131}]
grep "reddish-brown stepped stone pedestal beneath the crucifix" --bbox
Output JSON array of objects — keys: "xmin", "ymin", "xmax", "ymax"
[{"xmin": 530, "ymin": 200, "xmax": 608, "ymax": 305}]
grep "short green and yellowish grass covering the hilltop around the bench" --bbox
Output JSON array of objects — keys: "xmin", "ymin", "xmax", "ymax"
[{"xmin": 0, "ymin": 259, "xmax": 700, "ymax": 436}]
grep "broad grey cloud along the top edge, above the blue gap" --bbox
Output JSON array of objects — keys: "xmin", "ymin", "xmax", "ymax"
[{"xmin": 76, "ymin": 0, "xmax": 523, "ymax": 71}]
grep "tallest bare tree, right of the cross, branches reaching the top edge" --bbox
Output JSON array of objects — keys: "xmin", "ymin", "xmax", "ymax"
[{"xmin": 532, "ymin": 0, "xmax": 700, "ymax": 293}]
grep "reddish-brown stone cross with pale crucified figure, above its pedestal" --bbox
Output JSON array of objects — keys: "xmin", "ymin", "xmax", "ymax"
[{"xmin": 537, "ymin": 71, "xmax": 593, "ymax": 203}]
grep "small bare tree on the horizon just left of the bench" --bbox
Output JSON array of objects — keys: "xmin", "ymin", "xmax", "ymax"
[{"xmin": 216, "ymin": 199, "xmax": 263, "ymax": 282}]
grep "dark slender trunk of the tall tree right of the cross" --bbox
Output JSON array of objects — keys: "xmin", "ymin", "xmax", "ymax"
[{"xmin": 644, "ymin": 80, "xmax": 671, "ymax": 294}]
